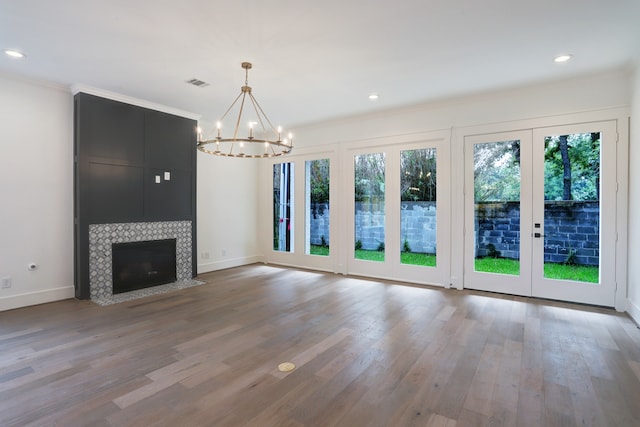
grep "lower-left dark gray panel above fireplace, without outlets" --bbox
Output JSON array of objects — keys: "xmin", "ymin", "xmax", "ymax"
[{"xmin": 86, "ymin": 163, "xmax": 144, "ymax": 224}]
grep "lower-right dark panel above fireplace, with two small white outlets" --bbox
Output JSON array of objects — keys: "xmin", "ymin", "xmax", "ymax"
[{"xmin": 144, "ymin": 169, "xmax": 194, "ymax": 221}]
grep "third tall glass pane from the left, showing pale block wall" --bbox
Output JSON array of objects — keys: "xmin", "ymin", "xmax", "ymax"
[{"xmin": 354, "ymin": 153, "xmax": 385, "ymax": 261}]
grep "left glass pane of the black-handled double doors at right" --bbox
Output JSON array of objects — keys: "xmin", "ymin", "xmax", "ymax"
[{"xmin": 473, "ymin": 141, "xmax": 520, "ymax": 275}]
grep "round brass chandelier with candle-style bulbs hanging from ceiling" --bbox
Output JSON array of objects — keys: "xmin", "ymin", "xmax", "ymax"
[{"xmin": 198, "ymin": 62, "xmax": 293, "ymax": 158}]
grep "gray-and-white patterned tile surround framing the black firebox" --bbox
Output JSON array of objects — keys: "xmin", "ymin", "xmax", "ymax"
[{"xmin": 89, "ymin": 221, "xmax": 192, "ymax": 302}]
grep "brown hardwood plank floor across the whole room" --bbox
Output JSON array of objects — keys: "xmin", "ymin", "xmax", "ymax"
[{"xmin": 0, "ymin": 265, "xmax": 640, "ymax": 427}]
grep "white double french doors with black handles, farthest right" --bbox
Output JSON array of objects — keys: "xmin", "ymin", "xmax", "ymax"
[{"xmin": 464, "ymin": 121, "xmax": 617, "ymax": 306}]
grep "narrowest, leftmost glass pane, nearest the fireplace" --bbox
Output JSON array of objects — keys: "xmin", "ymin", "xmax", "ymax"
[{"xmin": 273, "ymin": 163, "xmax": 293, "ymax": 252}]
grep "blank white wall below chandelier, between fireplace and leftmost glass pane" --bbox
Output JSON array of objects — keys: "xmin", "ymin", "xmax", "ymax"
[{"xmin": 197, "ymin": 150, "xmax": 263, "ymax": 273}]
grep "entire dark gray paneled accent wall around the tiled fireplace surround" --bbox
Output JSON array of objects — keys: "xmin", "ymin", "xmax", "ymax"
[{"xmin": 74, "ymin": 92, "xmax": 197, "ymax": 299}]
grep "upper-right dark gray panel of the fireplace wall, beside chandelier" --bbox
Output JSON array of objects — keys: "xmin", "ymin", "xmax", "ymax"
[{"xmin": 145, "ymin": 110, "xmax": 196, "ymax": 169}]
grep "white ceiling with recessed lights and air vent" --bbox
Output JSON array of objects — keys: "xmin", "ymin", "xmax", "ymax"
[{"xmin": 0, "ymin": 0, "xmax": 640, "ymax": 128}]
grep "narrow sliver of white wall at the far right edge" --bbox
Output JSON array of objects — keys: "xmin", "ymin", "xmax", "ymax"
[{"xmin": 628, "ymin": 65, "xmax": 640, "ymax": 324}]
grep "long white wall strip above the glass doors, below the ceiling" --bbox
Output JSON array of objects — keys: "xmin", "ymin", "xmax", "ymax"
[{"xmin": 293, "ymin": 69, "xmax": 631, "ymax": 148}]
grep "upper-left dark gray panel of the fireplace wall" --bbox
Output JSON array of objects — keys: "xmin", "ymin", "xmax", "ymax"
[{"xmin": 79, "ymin": 94, "xmax": 144, "ymax": 166}]
